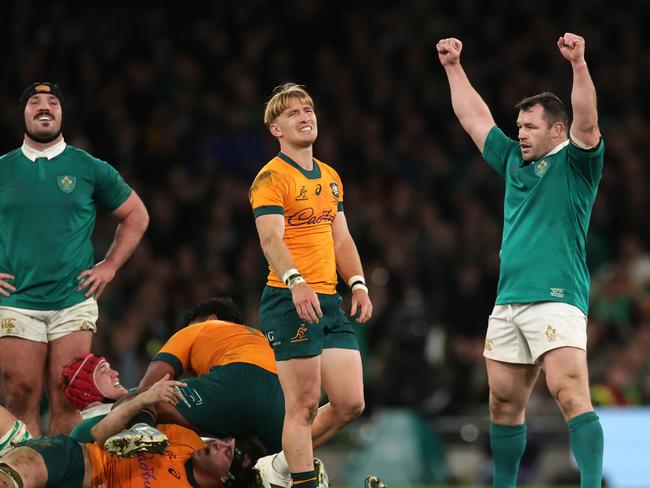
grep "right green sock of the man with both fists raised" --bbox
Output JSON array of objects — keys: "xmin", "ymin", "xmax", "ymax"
[{"xmin": 567, "ymin": 412, "xmax": 604, "ymax": 488}]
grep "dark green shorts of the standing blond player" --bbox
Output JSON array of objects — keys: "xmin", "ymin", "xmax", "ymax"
[{"xmin": 260, "ymin": 286, "xmax": 359, "ymax": 361}]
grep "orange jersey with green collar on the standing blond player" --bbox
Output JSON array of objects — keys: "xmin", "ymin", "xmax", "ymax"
[{"xmin": 249, "ymin": 152, "xmax": 343, "ymax": 295}]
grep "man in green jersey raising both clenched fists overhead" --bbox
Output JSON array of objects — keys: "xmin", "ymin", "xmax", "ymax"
[{"xmin": 436, "ymin": 33, "xmax": 604, "ymax": 488}]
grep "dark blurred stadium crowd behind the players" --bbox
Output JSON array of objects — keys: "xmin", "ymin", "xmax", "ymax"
[{"xmin": 0, "ymin": 0, "xmax": 650, "ymax": 420}]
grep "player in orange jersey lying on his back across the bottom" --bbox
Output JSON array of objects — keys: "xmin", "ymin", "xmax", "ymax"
[{"xmin": 0, "ymin": 379, "xmax": 264, "ymax": 488}]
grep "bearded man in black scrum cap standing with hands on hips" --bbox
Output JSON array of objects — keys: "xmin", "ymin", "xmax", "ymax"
[{"xmin": 0, "ymin": 82, "xmax": 149, "ymax": 435}]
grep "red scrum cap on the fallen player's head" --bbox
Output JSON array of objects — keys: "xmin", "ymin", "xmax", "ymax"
[{"xmin": 62, "ymin": 353, "xmax": 106, "ymax": 410}]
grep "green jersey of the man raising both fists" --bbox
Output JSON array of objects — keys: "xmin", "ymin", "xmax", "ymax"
[{"xmin": 483, "ymin": 126, "xmax": 605, "ymax": 315}]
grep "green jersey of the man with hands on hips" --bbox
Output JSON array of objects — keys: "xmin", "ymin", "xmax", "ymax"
[{"xmin": 0, "ymin": 142, "xmax": 132, "ymax": 310}]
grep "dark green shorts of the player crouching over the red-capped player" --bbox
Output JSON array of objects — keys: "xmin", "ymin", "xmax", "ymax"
[{"xmin": 176, "ymin": 363, "xmax": 284, "ymax": 452}]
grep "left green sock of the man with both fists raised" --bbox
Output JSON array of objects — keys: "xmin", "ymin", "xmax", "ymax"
[{"xmin": 490, "ymin": 422, "xmax": 526, "ymax": 488}]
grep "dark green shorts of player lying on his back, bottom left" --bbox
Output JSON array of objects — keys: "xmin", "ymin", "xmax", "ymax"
[{"xmin": 19, "ymin": 435, "xmax": 85, "ymax": 488}]
